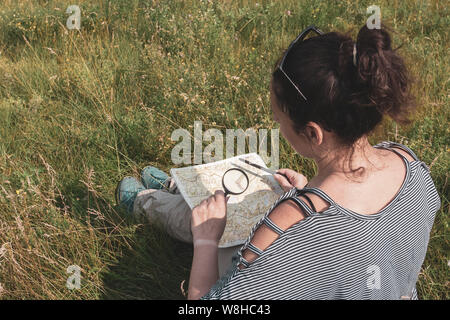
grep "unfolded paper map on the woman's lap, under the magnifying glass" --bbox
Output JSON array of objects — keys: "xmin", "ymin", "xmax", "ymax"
[{"xmin": 170, "ymin": 153, "xmax": 283, "ymax": 248}]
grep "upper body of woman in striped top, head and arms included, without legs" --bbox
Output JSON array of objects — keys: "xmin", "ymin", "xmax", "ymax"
[{"xmin": 115, "ymin": 26, "xmax": 440, "ymax": 299}]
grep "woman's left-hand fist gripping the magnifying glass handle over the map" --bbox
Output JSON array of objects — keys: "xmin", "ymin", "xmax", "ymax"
[{"xmin": 191, "ymin": 190, "xmax": 228, "ymax": 242}]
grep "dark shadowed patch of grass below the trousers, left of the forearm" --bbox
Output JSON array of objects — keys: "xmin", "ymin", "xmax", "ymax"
[{"xmin": 101, "ymin": 224, "xmax": 193, "ymax": 300}]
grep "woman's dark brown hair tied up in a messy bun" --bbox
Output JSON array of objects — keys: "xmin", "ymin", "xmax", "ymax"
[{"xmin": 272, "ymin": 26, "xmax": 414, "ymax": 146}]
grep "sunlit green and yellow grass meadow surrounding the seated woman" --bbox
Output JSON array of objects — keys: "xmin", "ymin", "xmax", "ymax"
[{"xmin": 0, "ymin": 0, "xmax": 450, "ymax": 299}]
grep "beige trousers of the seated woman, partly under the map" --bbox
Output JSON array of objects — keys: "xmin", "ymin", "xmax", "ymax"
[{"xmin": 133, "ymin": 178, "xmax": 241, "ymax": 276}]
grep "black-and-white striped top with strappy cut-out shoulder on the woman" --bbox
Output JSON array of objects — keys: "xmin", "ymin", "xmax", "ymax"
[{"xmin": 201, "ymin": 141, "xmax": 441, "ymax": 300}]
